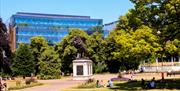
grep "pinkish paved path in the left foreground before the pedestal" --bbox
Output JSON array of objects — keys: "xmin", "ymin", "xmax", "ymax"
[{"xmin": 18, "ymin": 77, "xmax": 84, "ymax": 91}]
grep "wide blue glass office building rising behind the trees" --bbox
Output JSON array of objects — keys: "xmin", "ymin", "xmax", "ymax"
[{"xmin": 10, "ymin": 12, "xmax": 103, "ymax": 47}]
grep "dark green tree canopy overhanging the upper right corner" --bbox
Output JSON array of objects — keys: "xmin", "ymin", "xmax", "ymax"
[{"xmin": 117, "ymin": 0, "xmax": 180, "ymax": 42}]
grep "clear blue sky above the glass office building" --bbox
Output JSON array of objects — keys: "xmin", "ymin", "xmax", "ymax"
[{"xmin": 0, "ymin": 0, "xmax": 133, "ymax": 23}]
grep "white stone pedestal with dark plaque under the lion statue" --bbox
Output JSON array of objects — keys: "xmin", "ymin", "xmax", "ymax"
[{"xmin": 73, "ymin": 59, "xmax": 93, "ymax": 80}]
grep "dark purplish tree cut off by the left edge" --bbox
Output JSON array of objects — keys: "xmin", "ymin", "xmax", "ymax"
[{"xmin": 0, "ymin": 18, "xmax": 12, "ymax": 73}]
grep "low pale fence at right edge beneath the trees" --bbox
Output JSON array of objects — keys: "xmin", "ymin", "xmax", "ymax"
[{"xmin": 142, "ymin": 66, "xmax": 180, "ymax": 72}]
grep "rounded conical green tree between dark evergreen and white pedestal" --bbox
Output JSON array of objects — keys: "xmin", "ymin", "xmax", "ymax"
[{"xmin": 38, "ymin": 47, "xmax": 61, "ymax": 79}]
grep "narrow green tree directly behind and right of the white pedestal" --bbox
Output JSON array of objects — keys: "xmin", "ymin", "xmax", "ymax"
[{"xmin": 87, "ymin": 32, "xmax": 108, "ymax": 73}]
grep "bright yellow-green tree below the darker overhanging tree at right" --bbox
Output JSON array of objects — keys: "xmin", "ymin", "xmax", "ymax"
[{"xmin": 112, "ymin": 26, "xmax": 162, "ymax": 70}]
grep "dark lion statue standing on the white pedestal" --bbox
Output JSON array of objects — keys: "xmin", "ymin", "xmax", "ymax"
[{"xmin": 72, "ymin": 36, "xmax": 87, "ymax": 59}]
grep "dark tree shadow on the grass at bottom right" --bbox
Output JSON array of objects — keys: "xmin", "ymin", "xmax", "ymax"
[{"xmin": 110, "ymin": 79, "xmax": 180, "ymax": 91}]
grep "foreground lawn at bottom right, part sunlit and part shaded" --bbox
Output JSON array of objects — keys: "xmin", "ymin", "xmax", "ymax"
[{"xmin": 61, "ymin": 79, "xmax": 180, "ymax": 91}]
